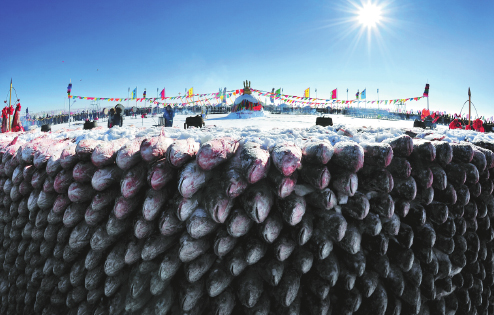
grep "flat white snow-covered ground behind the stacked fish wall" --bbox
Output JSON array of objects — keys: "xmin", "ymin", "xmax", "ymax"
[{"xmin": 5, "ymin": 112, "xmax": 494, "ymax": 148}]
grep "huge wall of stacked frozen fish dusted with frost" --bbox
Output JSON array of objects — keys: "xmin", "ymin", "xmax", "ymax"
[{"xmin": 0, "ymin": 135, "xmax": 494, "ymax": 315}]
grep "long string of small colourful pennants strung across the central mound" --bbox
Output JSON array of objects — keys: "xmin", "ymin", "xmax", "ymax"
[{"xmin": 68, "ymin": 88, "xmax": 423, "ymax": 106}]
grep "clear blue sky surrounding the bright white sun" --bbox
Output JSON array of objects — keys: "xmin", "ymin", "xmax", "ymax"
[{"xmin": 0, "ymin": 0, "xmax": 494, "ymax": 117}]
